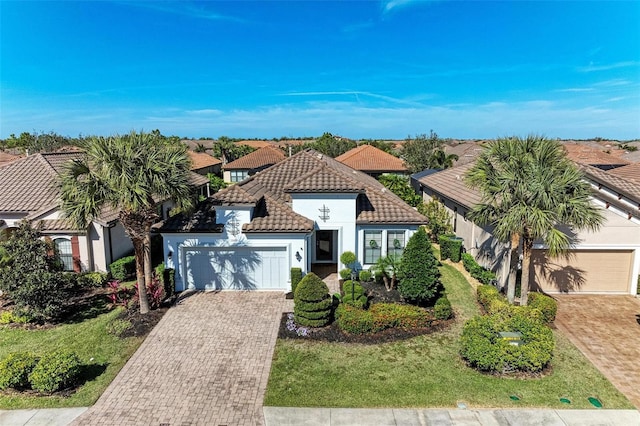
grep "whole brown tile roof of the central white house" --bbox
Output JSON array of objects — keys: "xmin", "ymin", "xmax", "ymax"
[{"xmin": 162, "ymin": 150, "xmax": 427, "ymax": 236}]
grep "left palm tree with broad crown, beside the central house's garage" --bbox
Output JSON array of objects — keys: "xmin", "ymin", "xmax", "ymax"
[{"xmin": 60, "ymin": 132, "xmax": 193, "ymax": 314}]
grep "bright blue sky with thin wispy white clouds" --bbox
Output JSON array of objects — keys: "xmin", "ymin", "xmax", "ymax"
[{"xmin": 0, "ymin": 0, "xmax": 640, "ymax": 140}]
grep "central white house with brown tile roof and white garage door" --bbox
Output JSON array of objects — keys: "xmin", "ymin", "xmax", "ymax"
[{"xmin": 160, "ymin": 150, "xmax": 426, "ymax": 291}]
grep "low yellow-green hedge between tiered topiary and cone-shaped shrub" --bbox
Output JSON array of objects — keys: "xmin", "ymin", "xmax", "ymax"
[{"xmin": 336, "ymin": 303, "xmax": 435, "ymax": 334}]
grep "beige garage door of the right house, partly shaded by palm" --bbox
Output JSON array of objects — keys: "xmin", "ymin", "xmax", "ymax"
[{"xmin": 531, "ymin": 250, "xmax": 633, "ymax": 293}]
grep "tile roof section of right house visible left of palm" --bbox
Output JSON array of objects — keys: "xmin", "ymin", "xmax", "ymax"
[{"xmin": 418, "ymin": 163, "xmax": 482, "ymax": 208}]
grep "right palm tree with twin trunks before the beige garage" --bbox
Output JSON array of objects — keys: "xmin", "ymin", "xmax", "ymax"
[{"xmin": 465, "ymin": 135, "xmax": 604, "ymax": 305}]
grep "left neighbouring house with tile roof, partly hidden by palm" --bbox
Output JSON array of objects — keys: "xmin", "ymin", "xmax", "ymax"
[{"xmin": 0, "ymin": 151, "xmax": 208, "ymax": 272}]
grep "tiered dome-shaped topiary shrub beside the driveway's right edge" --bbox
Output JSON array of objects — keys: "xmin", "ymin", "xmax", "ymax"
[{"xmin": 293, "ymin": 272, "xmax": 333, "ymax": 327}]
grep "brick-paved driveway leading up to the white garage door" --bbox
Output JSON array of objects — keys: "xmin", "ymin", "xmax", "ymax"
[{"xmin": 74, "ymin": 292, "xmax": 284, "ymax": 426}]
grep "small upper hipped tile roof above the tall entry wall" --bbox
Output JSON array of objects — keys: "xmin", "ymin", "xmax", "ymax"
[{"xmin": 284, "ymin": 164, "xmax": 364, "ymax": 192}]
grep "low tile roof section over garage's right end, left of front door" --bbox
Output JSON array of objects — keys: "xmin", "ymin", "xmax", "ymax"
[{"xmin": 242, "ymin": 195, "xmax": 314, "ymax": 233}]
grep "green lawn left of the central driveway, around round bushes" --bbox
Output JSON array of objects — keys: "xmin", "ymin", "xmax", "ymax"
[{"xmin": 0, "ymin": 310, "xmax": 143, "ymax": 409}]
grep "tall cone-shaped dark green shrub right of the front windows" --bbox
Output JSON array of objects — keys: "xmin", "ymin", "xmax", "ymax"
[{"xmin": 397, "ymin": 228, "xmax": 442, "ymax": 304}]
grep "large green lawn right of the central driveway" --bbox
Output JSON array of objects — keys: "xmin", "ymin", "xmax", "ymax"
[{"xmin": 264, "ymin": 265, "xmax": 633, "ymax": 408}]
